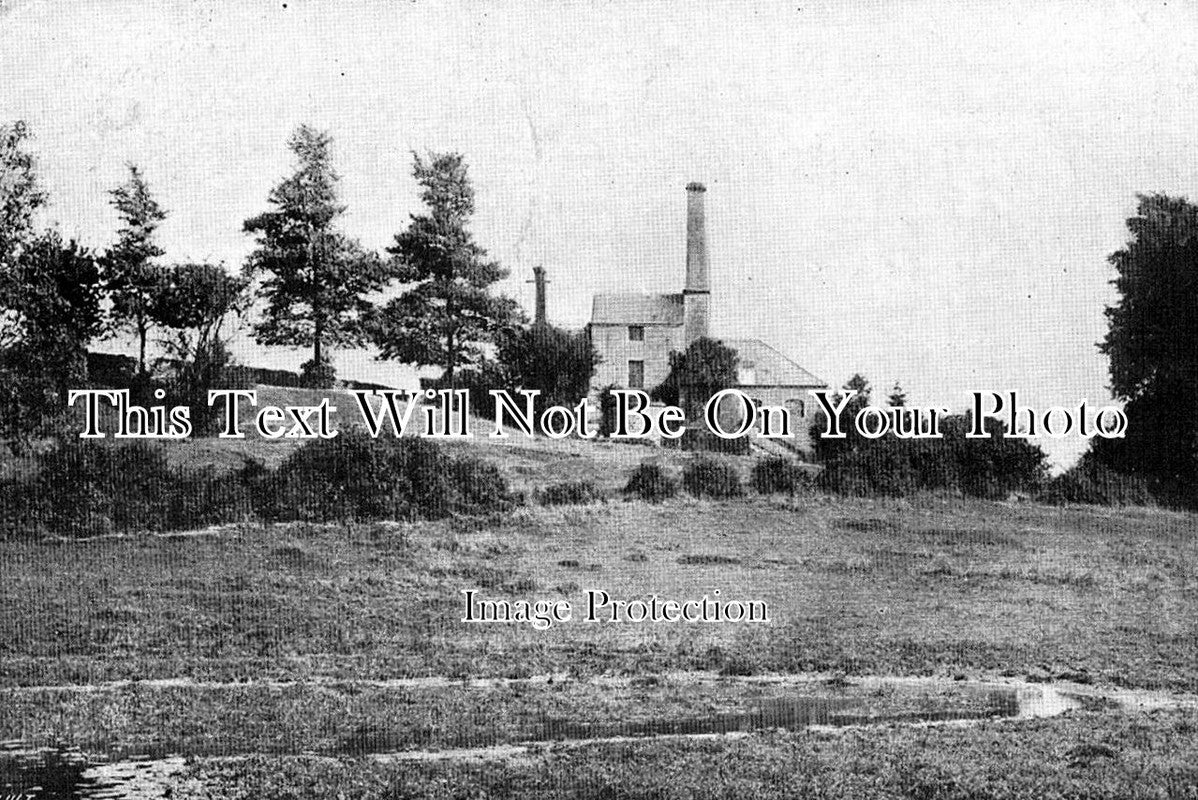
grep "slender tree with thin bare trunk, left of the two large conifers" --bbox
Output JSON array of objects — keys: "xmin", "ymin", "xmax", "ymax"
[{"xmin": 104, "ymin": 164, "xmax": 167, "ymax": 374}]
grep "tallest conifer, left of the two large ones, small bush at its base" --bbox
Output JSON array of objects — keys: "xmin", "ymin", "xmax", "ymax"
[{"xmin": 244, "ymin": 125, "xmax": 387, "ymax": 387}]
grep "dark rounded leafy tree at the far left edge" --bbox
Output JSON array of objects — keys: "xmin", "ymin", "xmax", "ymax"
[{"xmin": 0, "ymin": 231, "xmax": 103, "ymax": 432}]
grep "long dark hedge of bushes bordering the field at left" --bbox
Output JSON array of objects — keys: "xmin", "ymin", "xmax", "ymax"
[{"xmin": 0, "ymin": 432, "xmax": 515, "ymax": 537}]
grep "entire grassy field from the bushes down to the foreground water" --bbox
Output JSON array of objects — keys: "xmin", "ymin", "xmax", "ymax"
[{"xmin": 0, "ymin": 423, "xmax": 1198, "ymax": 798}]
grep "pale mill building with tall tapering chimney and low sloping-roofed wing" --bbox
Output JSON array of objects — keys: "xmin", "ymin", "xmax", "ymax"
[{"xmin": 588, "ymin": 183, "xmax": 828, "ymax": 449}]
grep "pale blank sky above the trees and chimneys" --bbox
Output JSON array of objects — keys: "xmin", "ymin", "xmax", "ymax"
[{"xmin": 0, "ymin": 0, "xmax": 1198, "ymax": 465}]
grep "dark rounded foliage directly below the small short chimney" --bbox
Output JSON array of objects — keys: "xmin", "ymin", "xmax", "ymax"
[{"xmin": 496, "ymin": 325, "xmax": 599, "ymax": 408}]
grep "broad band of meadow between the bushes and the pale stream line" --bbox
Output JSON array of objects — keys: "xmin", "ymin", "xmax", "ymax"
[{"xmin": 0, "ymin": 498, "xmax": 1198, "ymax": 691}]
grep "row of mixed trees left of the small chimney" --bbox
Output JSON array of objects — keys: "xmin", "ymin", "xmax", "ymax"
[{"xmin": 0, "ymin": 122, "xmax": 597, "ymax": 432}]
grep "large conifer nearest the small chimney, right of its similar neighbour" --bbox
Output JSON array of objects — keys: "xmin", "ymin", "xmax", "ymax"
[{"xmin": 373, "ymin": 153, "xmax": 521, "ymax": 386}]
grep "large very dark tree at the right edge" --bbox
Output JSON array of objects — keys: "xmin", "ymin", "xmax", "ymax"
[{"xmin": 1094, "ymin": 194, "xmax": 1198, "ymax": 503}]
